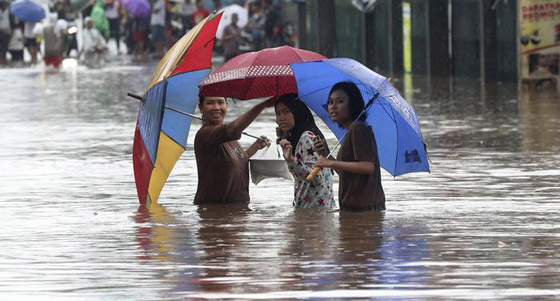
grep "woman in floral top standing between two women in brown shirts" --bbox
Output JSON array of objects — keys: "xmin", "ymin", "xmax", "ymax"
[{"xmin": 274, "ymin": 94, "xmax": 335, "ymax": 209}]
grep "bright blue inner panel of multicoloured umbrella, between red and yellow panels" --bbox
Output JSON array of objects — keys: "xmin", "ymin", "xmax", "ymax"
[{"xmin": 161, "ymin": 69, "xmax": 210, "ymax": 148}]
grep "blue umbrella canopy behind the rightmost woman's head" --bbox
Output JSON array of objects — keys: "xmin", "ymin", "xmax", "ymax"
[{"xmin": 290, "ymin": 58, "xmax": 430, "ymax": 176}]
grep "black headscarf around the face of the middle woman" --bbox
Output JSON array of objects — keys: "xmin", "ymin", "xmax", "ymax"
[{"xmin": 274, "ymin": 94, "xmax": 329, "ymax": 154}]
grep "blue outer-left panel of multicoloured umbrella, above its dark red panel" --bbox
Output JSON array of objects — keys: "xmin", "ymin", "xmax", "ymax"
[{"xmin": 138, "ymin": 81, "xmax": 166, "ymax": 165}]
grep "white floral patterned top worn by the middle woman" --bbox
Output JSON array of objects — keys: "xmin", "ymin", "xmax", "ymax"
[{"xmin": 288, "ymin": 131, "xmax": 335, "ymax": 209}]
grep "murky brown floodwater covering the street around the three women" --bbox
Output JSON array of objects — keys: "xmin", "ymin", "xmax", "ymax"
[{"xmin": 0, "ymin": 61, "xmax": 560, "ymax": 300}]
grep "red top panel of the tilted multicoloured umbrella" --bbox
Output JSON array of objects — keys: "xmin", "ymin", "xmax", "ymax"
[{"xmin": 171, "ymin": 14, "xmax": 222, "ymax": 75}]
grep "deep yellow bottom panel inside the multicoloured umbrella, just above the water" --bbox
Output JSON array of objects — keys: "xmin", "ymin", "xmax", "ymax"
[{"xmin": 148, "ymin": 132, "xmax": 185, "ymax": 204}]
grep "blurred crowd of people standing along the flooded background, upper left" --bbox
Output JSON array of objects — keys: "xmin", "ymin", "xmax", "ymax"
[{"xmin": 0, "ymin": 0, "xmax": 296, "ymax": 68}]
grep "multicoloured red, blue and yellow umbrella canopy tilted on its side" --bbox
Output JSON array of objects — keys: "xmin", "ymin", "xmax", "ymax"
[{"xmin": 132, "ymin": 14, "xmax": 221, "ymax": 205}]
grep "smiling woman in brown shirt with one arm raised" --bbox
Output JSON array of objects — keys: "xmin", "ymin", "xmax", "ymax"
[{"xmin": 194, "ymin": 97, "xmax": 276, "ymax": 204}]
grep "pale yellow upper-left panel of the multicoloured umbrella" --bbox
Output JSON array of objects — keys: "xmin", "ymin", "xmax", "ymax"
[{"xmin": 146, "ymin": 15, "xmax": 212, "ymax": 91}]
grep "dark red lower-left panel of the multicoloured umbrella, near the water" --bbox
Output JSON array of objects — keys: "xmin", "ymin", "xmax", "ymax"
[{"xmin": 132, "ymin": 123, "xmax": 154, "ymax": 206}]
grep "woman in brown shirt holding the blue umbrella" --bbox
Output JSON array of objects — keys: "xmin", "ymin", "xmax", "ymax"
[{"xmin": 315, "ymin": 82, "xmax": 385, "ymax": 211}]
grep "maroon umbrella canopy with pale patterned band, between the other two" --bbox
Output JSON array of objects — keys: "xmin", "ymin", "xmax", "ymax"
[{"xmin": 200, "ymin": 46, "xmax": 326, "ymax": 99}]
